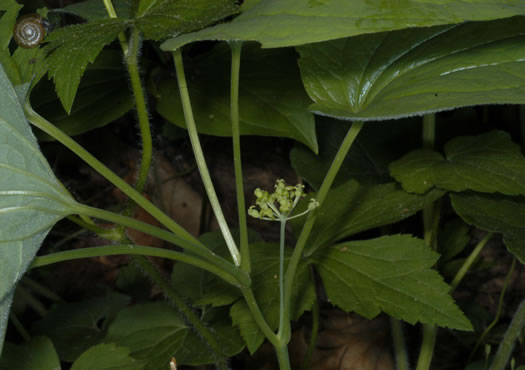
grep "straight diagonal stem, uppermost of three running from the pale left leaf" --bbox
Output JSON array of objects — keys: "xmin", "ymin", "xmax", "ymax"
[{"xmin": 25, "ymin": 101, "xmax": 206, "ymax": 248}]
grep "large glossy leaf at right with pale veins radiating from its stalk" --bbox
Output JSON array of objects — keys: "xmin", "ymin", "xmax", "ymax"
[{"xmin": 297, "ymin": 17, "xmax": 525, "ymax": 120}]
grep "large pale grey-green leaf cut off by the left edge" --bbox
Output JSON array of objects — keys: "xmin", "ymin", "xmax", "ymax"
[{"xmin": 0, "ymin": 66, "xmax": 74, "ymax": 356}]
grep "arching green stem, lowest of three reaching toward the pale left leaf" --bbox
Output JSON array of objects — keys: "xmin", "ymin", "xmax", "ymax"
[{"xmin": 29, "ymin": 244, "xmax": 238, "ymax": 285}]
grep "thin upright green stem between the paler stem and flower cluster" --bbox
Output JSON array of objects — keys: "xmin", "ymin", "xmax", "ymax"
[{"xmin": 229, "ymin": 41, "xmax": 251, "ymax": 273}]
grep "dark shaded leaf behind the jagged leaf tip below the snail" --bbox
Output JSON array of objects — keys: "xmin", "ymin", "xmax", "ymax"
[{"xmin": 31, "ymin": 50, "xmax": 135, "ymax": 141}]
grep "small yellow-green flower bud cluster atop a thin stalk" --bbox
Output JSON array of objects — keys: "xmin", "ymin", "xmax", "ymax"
[{"xmin": 248, "ymin": 179, "xmax": 319, "ymax": 221}]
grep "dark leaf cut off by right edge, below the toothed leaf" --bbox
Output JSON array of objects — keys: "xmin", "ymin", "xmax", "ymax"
[{"xmin": 450, "ymin": 193, "xmax": 525, "ymax": 263}]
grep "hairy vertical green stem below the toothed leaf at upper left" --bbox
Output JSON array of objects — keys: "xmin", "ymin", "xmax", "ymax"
[{"xmin": 125, "ymin": 27, "xmax": 153, "ymax": 193}]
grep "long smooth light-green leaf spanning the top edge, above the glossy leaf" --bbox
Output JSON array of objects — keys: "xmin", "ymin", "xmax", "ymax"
[{"xmin": 161, "ymin": 0, "xmax": 525, "ymax": 49}]
